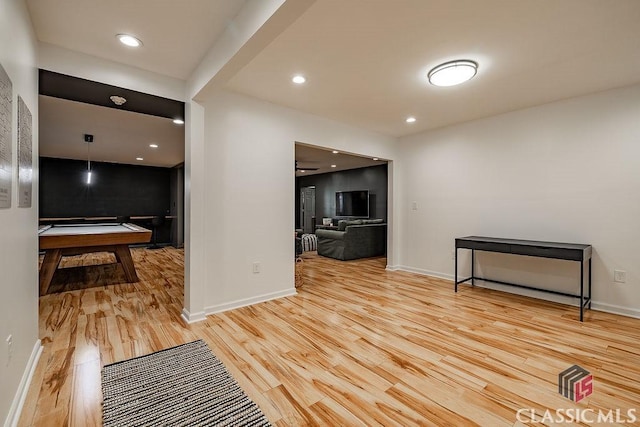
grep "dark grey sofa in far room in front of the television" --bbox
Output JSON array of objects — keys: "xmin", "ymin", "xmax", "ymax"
[{"xmin": 316, "ymin": 219, "xmax": 387, "ymax": 261}]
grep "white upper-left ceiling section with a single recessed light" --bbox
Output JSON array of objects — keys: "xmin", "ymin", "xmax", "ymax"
[{"xmin": 27, "ymin": 0, "xmax": 245, "ymax": 80}]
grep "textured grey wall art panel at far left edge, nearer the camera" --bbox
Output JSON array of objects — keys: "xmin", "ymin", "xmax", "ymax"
[{"xmin": 0, "ymin": 65, "xmax": 13, "ymax": 208}]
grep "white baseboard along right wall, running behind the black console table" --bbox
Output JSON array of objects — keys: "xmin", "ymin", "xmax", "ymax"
[{"xmin": 387, "ymin": 265, "xmax": 640, "ymax": 319}]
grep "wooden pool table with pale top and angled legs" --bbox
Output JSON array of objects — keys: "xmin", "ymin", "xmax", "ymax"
[{"xmin": 38, "ymin": 223, "xmax": 151, "ymax": 295}]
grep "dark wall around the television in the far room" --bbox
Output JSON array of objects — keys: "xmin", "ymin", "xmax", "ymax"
[{"xmin": 295, "ymin": 163, "xmax": 387, "ymax": 228}]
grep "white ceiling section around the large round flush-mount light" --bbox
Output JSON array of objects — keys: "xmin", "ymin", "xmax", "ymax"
[{"xmin": 229, "ymin": 0, "xmax": 640, "ymax": 136}]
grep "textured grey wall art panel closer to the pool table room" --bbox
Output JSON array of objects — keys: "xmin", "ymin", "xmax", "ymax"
[{"xmin": 18, "ymin": 96, "xmax": 33, "ymax": 208}]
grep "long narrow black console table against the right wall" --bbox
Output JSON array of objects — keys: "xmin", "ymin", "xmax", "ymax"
[{"xmin": 455, "ymin": 236, "xmax": 591, "ymax": 322}]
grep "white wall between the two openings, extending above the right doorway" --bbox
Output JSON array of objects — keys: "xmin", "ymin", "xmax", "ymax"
[{"xmin": 190, "ymin": 92, "xmax": 395, "ymax": 313}]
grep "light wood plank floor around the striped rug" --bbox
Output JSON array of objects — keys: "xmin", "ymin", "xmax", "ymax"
[{"xmin": 20, "ymin": 248, "xmax": 640, "ymax": 426}]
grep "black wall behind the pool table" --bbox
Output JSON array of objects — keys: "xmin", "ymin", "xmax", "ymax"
[{"xmin": 39, "ymin": 157, "xmax": 171, "ymax": 218}]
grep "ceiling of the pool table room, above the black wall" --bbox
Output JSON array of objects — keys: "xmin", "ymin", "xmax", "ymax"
[{"xmin": 38, "ymin": 95, "xmax": 184, "ymax": 167}]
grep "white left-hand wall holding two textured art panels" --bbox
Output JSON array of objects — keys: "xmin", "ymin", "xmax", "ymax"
[{"xmin": 0, "ymin": 0, "xmax": 39, "ymax": 424}]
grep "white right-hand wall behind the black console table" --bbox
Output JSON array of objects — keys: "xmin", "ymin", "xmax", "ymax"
[{"xmin": 400, "ymin": 86, "xmax": 640, "ymax": 316}]
